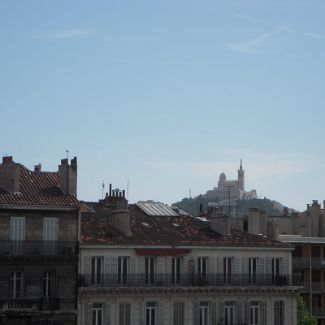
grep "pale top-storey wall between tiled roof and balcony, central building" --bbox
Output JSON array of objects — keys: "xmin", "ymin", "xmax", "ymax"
[{"xmin": 80, "ymin": 246, "xmax": 291, "ymax": 274}]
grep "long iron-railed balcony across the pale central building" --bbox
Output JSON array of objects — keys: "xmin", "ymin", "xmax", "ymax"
[{"xmin": 79, "ymin": 274, "xmax": 294, "ymax": 288}]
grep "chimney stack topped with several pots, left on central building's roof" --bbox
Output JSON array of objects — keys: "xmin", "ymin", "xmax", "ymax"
[{"xmin": 100, "ymin": 184, "xmax": 131, "ymax": 236}]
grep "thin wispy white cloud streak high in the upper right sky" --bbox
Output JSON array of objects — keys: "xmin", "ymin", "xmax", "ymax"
[{"xmin": 227, "ymin": 27, "xmax": 287, "ymax": 53}]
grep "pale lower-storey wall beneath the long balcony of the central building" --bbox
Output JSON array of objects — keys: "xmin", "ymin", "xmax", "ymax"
[{"xmin": 78, "ymin": 289, "xmax": 297, "ymax": 325}]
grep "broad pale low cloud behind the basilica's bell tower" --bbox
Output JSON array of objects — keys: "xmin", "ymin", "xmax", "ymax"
[{"xmin": 145, "ymin": 149, "xmax": 322, "ymax": 184}]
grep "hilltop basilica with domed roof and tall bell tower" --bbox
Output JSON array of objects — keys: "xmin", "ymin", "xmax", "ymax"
[{"xmin": 206, "ymin": 160, "xmax": 257, "ymax": 206}]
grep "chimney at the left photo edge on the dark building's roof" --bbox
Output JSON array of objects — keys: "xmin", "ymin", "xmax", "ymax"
[{"xmin": 0, "ymin": 156, "xmax": 20, "ymax": 193}]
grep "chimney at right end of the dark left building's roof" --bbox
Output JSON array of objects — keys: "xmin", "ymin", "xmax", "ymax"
[{"xmin": 59, "ymin": 157, "xmax": 77, "ymax": 196}]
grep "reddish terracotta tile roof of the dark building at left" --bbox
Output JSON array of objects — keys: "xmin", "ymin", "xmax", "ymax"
[{"xmin": 0, "ymin": 165, "xmax": 79, "ymax": 206}]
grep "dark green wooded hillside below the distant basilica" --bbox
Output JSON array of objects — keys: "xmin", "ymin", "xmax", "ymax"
[{"xmin": 173, "ymin": 195, "xmax": 284, "ymax": 217}]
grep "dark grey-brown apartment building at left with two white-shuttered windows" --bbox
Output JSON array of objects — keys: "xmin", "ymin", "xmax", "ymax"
[{"xmin": 0, "ymin": 157, "xmax": 79, "ymax": 325}]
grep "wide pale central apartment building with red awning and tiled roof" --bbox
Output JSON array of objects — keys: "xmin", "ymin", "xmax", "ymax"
[{"xmin": 78, "ymin": 188, "xmax": 298, "ymax": 325}]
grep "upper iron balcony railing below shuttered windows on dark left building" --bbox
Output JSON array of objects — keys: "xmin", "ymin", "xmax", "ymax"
[{"xmin": 0, "ymin": 240, "xmax": 78, "ymax": 257}]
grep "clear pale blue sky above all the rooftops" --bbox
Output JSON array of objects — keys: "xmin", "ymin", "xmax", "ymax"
[{"xmin": 0, "ymin": 0, "xmax": 325, "ymax": 210}]
